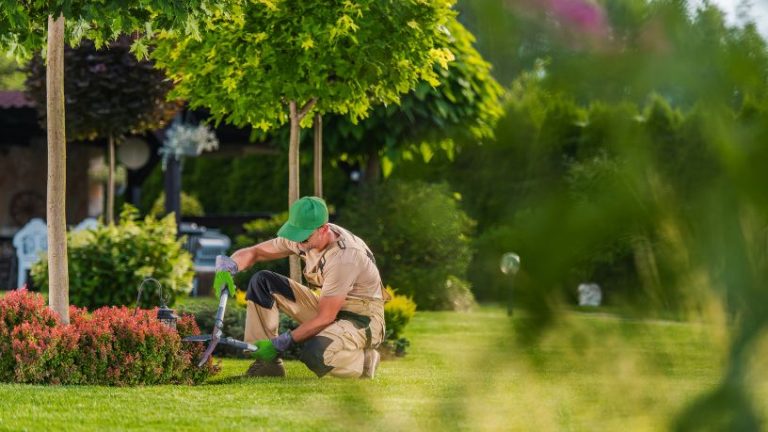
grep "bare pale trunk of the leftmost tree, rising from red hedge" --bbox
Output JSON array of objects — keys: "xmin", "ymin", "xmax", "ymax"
[{"xmin": 46, "ymin": 15, "xmax": 69, "ymax": 324}]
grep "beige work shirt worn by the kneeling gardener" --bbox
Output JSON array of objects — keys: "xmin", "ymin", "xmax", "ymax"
[{"xmin": 271, "ymin": 224, "xmax": 383, "ymax": 299}]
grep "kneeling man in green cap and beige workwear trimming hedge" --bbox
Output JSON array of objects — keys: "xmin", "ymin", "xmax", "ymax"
[{"xmin": 214, "ymin": 197, "xmax": 387, "ymax": 378}]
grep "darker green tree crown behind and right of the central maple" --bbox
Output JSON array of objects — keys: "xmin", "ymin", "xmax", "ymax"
[{"xmin": 325, "ymin": 18, "xmax": 504, "ymax": 182}]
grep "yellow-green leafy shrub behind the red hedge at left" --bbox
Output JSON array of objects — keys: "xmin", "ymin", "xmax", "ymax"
[{"xmin": 32, "ymin": 206, "xmax": 194, "ymax": 308}]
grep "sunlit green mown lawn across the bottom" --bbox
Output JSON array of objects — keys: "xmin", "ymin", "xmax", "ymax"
[{"xmin": 0, "ymin": 308, "xmax": 768, "ymax": 431}]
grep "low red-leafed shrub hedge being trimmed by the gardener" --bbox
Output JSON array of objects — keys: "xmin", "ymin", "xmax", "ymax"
[{"xmin": 0, "ymin": 291, "xmax": 217, "ymax": 386}]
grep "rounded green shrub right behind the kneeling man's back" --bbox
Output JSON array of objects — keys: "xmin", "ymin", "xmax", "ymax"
[{"xmin": 339, "ymin": 181, "xmax": 474, "ymax": 309}]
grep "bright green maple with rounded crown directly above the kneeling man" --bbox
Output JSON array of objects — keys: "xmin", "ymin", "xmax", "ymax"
[{"xmin": 154, "ymin": 0, "xmax": 460, "ymax": 279}]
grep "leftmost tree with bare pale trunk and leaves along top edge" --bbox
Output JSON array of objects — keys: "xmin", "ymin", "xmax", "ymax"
[{"xmin": 0, "ymin": 0, "xmax": 218, "ymax": 323}]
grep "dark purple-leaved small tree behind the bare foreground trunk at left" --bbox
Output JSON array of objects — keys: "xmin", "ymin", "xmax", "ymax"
[{"xmin": 26, "ymin": 36, "xmax": 179, "ymax": 223}]
